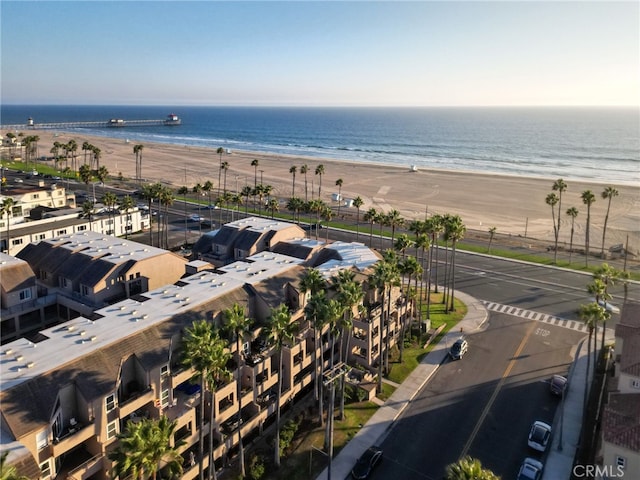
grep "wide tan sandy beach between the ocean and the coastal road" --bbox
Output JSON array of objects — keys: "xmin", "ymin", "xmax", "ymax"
[{"xmin": 20, "ymin": 130, "xmax": 640, "ymax": 254}]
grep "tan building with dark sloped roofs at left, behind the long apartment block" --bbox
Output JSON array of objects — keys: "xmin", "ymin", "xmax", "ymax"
[{"xmin": 0, "ymin": 231, "xmax": 186, "ymax": 343}]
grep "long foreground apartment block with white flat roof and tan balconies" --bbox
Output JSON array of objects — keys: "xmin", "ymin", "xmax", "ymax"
[{"xmin": 0, "ymin": 226, "xmax": 410, "ymax": 480}]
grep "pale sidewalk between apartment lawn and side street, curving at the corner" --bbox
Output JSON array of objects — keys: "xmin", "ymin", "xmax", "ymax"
[{"xmin": 317, "ymin": 292, "xmax": 489, "ymax": 480}]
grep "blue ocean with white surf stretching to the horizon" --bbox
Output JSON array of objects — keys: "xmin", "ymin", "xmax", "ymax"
[{"xmin": 0, "ymin": 105, "xmax": 640, "ymax": 186}]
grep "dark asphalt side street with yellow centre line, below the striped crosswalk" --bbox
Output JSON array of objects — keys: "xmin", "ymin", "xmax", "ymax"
[{"xmin": 372, "ymin": 313, "xmax": 584, "ymax": 480}]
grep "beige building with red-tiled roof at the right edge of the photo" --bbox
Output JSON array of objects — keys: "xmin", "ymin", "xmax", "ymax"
[{"xmin": 600, "ymin": 302, "xmax": 640, "ymax": 478}]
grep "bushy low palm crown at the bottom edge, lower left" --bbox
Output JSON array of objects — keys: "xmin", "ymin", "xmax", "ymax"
[{"xmin": 109, "ymin": 416, "xmax": 184, "ymax": 480}]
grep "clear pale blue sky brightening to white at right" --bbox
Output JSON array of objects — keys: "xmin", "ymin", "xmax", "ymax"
[{"xmin": 0, "ymin": 0, "xmax": 640, "ymax": 106}]
